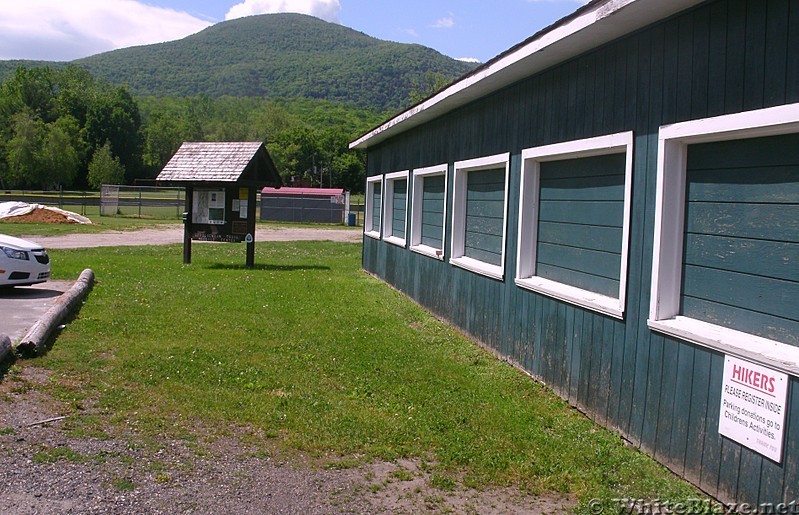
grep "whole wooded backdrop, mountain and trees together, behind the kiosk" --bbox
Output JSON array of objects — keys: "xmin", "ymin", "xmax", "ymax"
[{"xmin": 0, "ymin": 14, "xmax": 482, "ymax": 192}]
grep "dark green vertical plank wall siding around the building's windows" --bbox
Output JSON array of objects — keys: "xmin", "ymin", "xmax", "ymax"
[{"xmin": 363, "ymin": 0, "xmax": 799, "ymax": 504}]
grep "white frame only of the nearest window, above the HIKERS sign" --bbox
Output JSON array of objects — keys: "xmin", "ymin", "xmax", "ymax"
[{"xmin": 647, "ymin": 104, "xmax": 799, "ymax": 375}]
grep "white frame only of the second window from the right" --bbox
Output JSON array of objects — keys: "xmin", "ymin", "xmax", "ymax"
[{"xmin": 515, "ymin": 131, "xmax": 633, "ymax": 319}]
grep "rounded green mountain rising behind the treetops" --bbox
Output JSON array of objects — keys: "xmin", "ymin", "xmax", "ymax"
[{"xmin": 0, "ymin": 14, "xmax": 476, "ymax": 111}]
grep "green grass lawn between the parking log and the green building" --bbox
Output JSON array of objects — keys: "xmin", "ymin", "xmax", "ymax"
[{"xmin": 20, "ymin": 242, "xmax": 698, "ymax": 513}]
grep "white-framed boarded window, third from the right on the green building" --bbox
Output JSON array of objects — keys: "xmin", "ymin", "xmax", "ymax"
[{"xmin": 450, "ymin": 153, "xmax": 510, "ymax": 279}]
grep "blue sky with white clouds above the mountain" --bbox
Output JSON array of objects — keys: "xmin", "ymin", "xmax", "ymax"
[{"xmin": 0, "ymin": 0, "xmax": 586, "ymax": 62}]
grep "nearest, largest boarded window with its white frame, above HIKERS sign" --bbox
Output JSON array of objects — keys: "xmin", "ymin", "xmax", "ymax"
[{"xmin": 648, "ymin": 104, "xmax": 799, "ymax": 374}]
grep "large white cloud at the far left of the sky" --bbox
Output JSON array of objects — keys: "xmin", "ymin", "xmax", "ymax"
[{"xmin": 0, "ymin": 0, "xmax": 211, "ymax": 61}]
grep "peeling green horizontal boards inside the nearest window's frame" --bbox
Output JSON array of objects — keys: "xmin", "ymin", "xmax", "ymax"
[{"xmin": 681, "ymin": 133, "xmax": 799, "ymax": 346}]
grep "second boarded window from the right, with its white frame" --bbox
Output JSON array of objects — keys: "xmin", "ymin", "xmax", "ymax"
[{"xmin": 516, "ymin": 132, "xmax": 633, "ymax": 318}]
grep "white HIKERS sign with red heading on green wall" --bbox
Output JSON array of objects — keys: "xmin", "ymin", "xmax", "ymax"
[{"xmin": 719, "ymin": 356, "xmax": 788, "ymax": 463}]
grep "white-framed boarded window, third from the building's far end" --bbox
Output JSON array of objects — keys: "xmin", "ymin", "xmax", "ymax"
[{"xmin": 411, "ymin": 164, "xmax": 447, "ymax": 259}]
